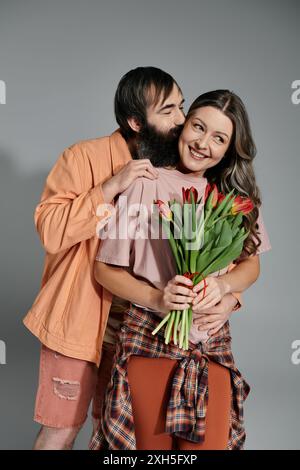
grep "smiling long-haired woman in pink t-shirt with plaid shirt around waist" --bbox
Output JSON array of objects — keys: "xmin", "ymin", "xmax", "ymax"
[{"xmin": 90, "ymin": 90, "xmax": 271, "ymax": 450}]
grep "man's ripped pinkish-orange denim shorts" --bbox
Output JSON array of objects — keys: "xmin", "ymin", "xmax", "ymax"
[{"xmin": 34, "ymin": 343, "xmax": 115, "ymax": 428}]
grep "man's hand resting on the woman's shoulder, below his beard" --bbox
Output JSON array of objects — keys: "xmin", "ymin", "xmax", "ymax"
[{"xmin": 102, "ymin": 158, "xmax": 158, "ymax": 203}]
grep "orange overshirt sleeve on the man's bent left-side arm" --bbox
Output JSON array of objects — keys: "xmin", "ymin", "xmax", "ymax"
[{"xmin": 34, "ymin": 145, "xmax": 105, "ymax": 254}]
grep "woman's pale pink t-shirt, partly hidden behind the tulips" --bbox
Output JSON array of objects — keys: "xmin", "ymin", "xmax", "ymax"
[{"xmin": 96, "ymin": 168, "xmax": 271, "ymax": 342}]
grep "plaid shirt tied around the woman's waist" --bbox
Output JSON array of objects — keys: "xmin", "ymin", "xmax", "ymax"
[{"xmin": 89, "ymin": 305, "xmax": 250, "ymax": 450}]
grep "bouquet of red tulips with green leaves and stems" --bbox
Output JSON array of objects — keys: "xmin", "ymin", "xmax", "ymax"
[{"xmin": 152, "ymin": 184, "xmax": 253, "ymax": 350}]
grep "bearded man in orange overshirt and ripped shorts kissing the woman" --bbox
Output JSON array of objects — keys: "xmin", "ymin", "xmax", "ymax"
[{"xmin": 24, "ymin": 67, "xmax": 240, "ymax": 450}]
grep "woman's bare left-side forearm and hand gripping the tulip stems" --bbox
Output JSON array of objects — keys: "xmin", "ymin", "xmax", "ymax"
[{"xmin": 94, "ymin": 261, "xmax": 193, "ymax": 316}]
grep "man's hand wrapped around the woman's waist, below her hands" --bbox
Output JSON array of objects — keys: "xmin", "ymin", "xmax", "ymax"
[{"xmin": 193, "ymin": 294, "xmax": 237, "ymax": 336}]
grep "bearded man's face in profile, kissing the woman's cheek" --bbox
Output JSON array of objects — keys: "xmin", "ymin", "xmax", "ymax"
[{"xmin": 135, "ymin": 84, "xmax": 185, "ymax": 167}]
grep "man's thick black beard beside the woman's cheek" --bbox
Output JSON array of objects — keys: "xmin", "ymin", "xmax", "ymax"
[{"xmin": 133, "ymin": 123, "xmax": 183, "ymax": 167}]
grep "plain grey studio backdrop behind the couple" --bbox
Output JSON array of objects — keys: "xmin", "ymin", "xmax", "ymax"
[{"xmin": 0, "ymin": 0, "xmax": 300, "ymax": 449}]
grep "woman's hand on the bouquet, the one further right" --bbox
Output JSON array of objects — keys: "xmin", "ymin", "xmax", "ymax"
[{"xmin": 192, "ymin": 276, "xmax": 229, "ymax": 313}]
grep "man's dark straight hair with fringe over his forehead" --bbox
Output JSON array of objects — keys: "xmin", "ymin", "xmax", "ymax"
[{"xmin": 114, "ymin": 67, "xmax": 181, "ymax": 139}]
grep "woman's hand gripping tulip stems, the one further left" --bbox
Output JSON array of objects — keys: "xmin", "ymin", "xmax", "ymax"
[{"xmin": 157, "ymin": 274, "xmax": 197, "ymax": 313}]
